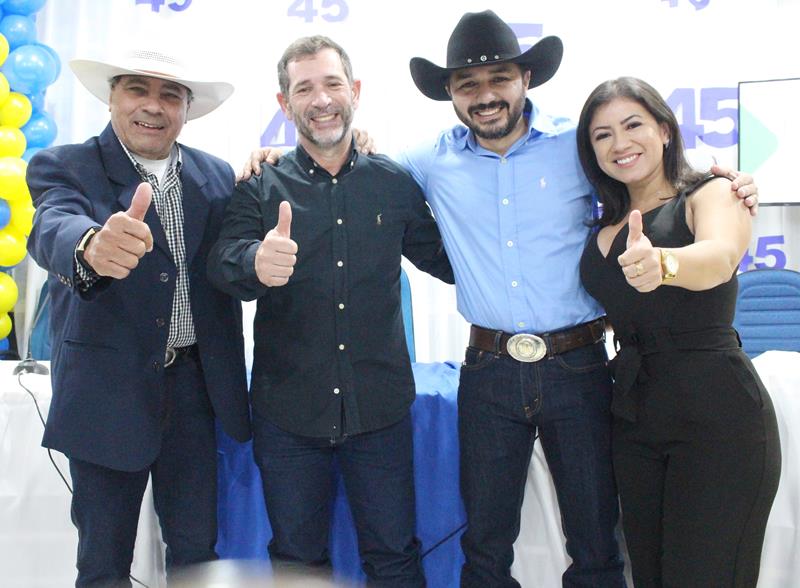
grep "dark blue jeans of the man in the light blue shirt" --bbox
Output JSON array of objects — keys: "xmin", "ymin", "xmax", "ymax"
[{"xmin": 458, "ymin": 343, "xmax": 625, "ymax": 588}]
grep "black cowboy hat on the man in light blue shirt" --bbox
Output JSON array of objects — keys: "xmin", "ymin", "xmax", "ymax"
[{"xmin": 409, "ymin": 10, "xmax": 564, "ymax": 100}]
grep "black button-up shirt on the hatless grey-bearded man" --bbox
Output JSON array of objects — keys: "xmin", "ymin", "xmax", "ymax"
[{"xmin": 208, "ymin": 147, "xmax": 453, "ymax": 437}]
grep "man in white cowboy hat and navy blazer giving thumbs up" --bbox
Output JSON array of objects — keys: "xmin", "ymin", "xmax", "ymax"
[{"xmin": 27, "ymin": 50, "xmax": 250, "ymax": 586}]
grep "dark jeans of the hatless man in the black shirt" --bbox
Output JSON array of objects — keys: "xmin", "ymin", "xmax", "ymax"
[{"xmin": 253, "ymin": 411, "xmax": 425, "ymax": 587}]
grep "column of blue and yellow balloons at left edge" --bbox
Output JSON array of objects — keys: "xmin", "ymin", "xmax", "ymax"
[{"xmin": 0, "ymin": 0, "xmax": 61, "ymax": 352}]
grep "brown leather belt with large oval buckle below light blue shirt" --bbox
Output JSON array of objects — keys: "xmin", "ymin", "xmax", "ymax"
[{"xmin": 469, "ymin": 318, "xmax": 606, "ymax": 362}]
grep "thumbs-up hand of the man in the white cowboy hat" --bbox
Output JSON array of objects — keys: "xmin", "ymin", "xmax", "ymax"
[{"xmin": 83, "ymin": 182, "xmax": 153, "ymax": 280}]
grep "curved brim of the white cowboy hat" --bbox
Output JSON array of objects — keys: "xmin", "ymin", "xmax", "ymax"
[{"xmin": 69, "ymin": 59, "xmax": 233, "ymax": 120}]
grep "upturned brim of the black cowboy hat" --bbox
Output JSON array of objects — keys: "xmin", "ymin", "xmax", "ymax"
[{"xmin": 409, "ymin": 36, "xmax": 564, "ymax": 100}]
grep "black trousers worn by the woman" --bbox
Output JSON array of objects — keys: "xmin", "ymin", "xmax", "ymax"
[{"xmin": 613, "ymin": 351, "xmax": 781, "ymax": 588}]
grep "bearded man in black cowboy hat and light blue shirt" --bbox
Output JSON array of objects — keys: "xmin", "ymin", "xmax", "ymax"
[{"xmin": 401, "ymin": 10, "xmax": 755, "ymax": 588}]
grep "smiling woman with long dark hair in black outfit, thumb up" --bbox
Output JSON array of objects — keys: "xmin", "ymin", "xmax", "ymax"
[{"xmin": 577, "ymin": 78, "xmax": 780, "ymax": 588}]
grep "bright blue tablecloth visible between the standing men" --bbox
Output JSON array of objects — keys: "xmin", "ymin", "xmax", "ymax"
[{"xmin": 217, "ymin": 363, "xmax": 465, "ymax": 588}]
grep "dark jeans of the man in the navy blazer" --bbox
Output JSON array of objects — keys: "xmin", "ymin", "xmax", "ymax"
[{"xmin": 69, "ymin": 359, "xmax": 217, "ymax": 586}]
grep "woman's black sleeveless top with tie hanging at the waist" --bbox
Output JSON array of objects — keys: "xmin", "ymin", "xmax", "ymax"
[{"xmin": 580, "ymin": 177, "xmax": 740, "ymax": 420}]
